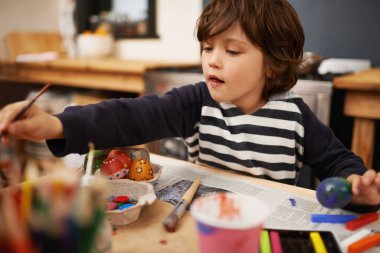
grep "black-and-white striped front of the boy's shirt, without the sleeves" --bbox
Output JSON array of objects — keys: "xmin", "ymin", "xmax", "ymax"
[{"xmin": 186, "ymin": 94, "xmax": 304, "ymax": 182}]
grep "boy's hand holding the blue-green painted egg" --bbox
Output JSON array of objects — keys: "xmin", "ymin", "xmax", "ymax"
[{"xmin": 347, "ymin": 169, "xmax": 380, "ymax": 205}]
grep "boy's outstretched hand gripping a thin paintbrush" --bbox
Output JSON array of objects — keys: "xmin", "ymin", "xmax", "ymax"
[{"xmin": 0, "ymin": 101, "xmax": 63, "ymax": 143}]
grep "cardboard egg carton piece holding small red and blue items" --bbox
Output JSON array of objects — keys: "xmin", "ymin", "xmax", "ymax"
[{"xmin": 106, "ymin": 179, "xmax": 157, "ymax": 226}]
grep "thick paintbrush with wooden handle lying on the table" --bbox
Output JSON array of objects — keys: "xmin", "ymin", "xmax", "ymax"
[{"xmin": 163, "ymin": 178, "xmax": 201, "ymax": 232}]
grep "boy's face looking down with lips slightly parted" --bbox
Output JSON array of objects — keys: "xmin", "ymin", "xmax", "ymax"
[{"xmin": 201, "ymin": 22, "xmax": 266, "ymax": 113}]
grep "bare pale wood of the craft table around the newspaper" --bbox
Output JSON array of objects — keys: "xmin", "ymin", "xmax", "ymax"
[{"xmin": 112, "ymin": 155, "xmax": 315, "ymax": 253}]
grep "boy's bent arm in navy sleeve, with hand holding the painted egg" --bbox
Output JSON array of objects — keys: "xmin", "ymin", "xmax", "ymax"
[{"xmin": 300, "ymin": 100, "xmax": 380, "ymax": 212}]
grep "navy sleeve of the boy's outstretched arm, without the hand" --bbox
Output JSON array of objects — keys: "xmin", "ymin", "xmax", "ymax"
[{"xmin": 47, "ymin": 85, "xmax": 204, "ymax": 156}]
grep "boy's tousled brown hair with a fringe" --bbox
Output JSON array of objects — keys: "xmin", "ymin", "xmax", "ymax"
[{"xmin": 197, "ymin": 0, "xmax": 305, "ymax": 98}]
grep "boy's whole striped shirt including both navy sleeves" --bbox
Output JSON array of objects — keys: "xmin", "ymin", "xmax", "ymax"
[{"xmin": 47, "ymin": 82, "xmax": 365, "ymax": 184}]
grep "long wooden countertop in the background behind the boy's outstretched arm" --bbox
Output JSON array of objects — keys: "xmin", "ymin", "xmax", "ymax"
[{"xmin": 0, "ymin": 58, "xmax": 199, "ymax": 95}]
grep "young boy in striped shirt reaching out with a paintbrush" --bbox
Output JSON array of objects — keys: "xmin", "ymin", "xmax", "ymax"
[{"xmin": 0, "ymin": 0, "xmax": 380, "ymax": 210}]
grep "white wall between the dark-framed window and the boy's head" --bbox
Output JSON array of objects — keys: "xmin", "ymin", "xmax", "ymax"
[{"xmin": 116, "ymin": 0, "xmax": 202, "ymax": 62}]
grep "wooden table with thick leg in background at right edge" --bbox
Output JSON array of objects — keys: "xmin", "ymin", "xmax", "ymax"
[{"xmin": 334, "ymin": 68, "xmax": 380, "ymax": 168}]
